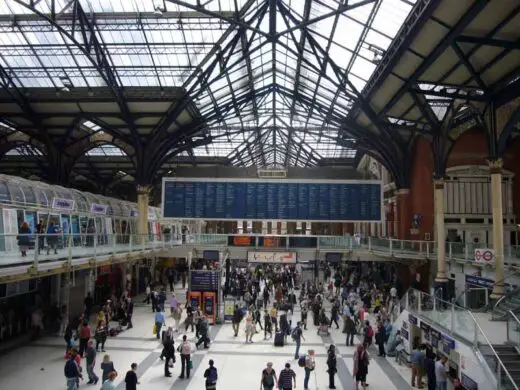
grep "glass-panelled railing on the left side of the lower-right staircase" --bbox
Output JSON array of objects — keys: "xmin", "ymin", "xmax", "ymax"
[{"xmin": 400, "ymin": 289, "xmax": 519, "ymax": 390}]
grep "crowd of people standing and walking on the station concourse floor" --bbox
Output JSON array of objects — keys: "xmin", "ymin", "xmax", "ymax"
[{"xmin": 58, "ymin": 258, "xmax": 468, "ymax": 390}]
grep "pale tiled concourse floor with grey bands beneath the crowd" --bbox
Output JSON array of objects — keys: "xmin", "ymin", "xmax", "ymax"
[{"xmin": 0, "ymin": 294, "xmax": 410, "ymax": 390}]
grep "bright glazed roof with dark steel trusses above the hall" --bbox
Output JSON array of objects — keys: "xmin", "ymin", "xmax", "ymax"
[{"xmin": 0, "ymin": 0, "xmax": 415, "ymax": 166}]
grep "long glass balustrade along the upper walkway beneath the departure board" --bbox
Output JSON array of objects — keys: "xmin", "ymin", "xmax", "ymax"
[{"xmin": 0, "ymin": 233, "xmax": 520, "ymax": 272}]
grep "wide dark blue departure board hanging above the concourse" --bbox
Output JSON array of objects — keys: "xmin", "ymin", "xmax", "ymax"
[{"xmin": 163, "ymin": 178, "xmax": 382, "ymax": 221}]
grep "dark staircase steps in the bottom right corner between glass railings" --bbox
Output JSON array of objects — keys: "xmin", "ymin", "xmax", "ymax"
[{"xmin": 479, "ymin": 344, "xmax": 520, "ymax": 390}]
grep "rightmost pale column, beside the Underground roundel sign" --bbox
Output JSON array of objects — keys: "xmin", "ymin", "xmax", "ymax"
[{"xmin": 489, "ymin": 159, "xmax": 504, "ymax": 299}]
